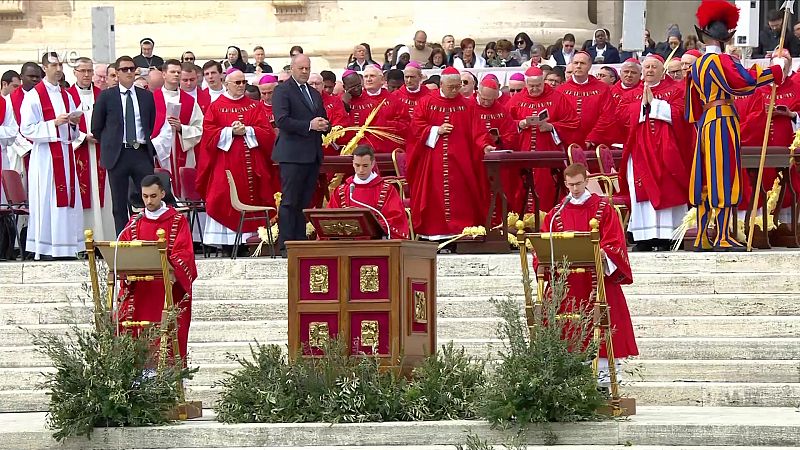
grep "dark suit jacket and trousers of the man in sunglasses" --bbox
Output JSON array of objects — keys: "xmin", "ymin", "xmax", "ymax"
[{"xmin": 92, "ymin": 86, "xmax": 156, "ymax": 233}]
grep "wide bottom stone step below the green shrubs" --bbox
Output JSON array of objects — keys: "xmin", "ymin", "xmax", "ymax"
[{"xmin": 0, "ymin": 406, "xmax": 800, "ymax": 450}]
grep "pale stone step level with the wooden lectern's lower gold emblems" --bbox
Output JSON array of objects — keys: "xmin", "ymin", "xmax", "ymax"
[{"xmin": 0, "ymin": 311, "xmax": 800, "ymax": 347}]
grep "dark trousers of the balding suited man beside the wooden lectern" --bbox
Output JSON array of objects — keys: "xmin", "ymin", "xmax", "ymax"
[{"xmin": 278, "ymin": 163, "xmax": 320, "ymax": 251}]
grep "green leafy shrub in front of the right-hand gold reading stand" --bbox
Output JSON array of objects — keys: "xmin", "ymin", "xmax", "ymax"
[{"xmin": 482, "ymin": 266, "xmax": 604, "ymax": 428}]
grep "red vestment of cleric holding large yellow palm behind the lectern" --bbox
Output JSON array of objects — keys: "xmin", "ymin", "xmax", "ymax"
[{"xmin": 344, "ymin": 89, "xmax": 409, "ymax": 153}]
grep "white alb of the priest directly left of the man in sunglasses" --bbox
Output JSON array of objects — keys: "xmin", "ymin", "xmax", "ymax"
[{"xmin": 72, "ymin": 88, "xmax": 117, "ymax": 241}]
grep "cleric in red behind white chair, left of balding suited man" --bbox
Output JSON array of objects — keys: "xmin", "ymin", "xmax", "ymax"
[{"xmin": 197, "ymin": 71, "xmax": 280, "ymax": 251}]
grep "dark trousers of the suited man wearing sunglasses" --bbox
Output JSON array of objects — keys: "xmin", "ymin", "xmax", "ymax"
[{"xmin": 107, "ymin": 145, "xmax": 153, "ymax": 235}]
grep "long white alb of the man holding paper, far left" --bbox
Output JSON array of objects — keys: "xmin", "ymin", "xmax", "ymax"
[{"xmin": 20, "ymin": 79, "xmax": 85, "ymax": 260}]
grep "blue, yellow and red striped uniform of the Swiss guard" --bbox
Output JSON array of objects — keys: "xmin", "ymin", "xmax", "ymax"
[{"xmin": 686, "ymin": 53, "xmax": 783, "ymax": 247}]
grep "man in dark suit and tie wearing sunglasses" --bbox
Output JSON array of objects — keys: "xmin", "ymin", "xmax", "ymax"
[{"xmin": 92, "ymin": 56, "xmax": 156, "ymax": 234}]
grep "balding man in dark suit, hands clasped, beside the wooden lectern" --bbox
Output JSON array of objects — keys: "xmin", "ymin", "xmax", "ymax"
[{"xmin": 272, "ymin": 53, "xmax": 330, "ymax": 256}]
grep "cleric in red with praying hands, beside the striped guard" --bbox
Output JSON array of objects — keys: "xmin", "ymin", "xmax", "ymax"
[{"xmin": 619, "ymin": 53, "xmax": 693, "ymax": 251}]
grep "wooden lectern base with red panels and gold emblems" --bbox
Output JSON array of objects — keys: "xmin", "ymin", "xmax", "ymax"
[{"xmin": 286, "ymin": 240, "xmax": 436, "ymax": 372}]
